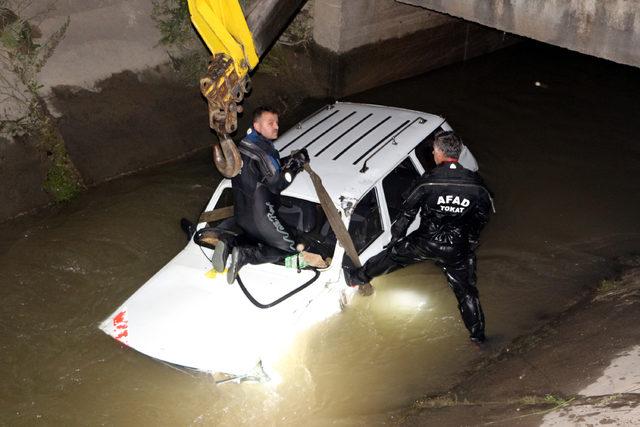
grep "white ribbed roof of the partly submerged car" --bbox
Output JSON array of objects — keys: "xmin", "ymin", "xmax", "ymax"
[{"xmin": 275, "ymin": 102, "xmax": 444, "ymax": 203}]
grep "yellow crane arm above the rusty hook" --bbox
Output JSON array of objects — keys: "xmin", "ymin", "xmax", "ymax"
[{"xmin": 188, "ymin": 0, "xmax": 259, "ymax": 77}]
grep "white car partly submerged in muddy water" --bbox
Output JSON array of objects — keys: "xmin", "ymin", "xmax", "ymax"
[{"xmin": 100, "ymin": 102, "xmax": 460, "ymax": 377}]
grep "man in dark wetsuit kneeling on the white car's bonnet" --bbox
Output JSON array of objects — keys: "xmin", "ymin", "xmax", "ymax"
[{"xmin": 213, "ymin": 107, "xmax": 308, "ymax": 283}]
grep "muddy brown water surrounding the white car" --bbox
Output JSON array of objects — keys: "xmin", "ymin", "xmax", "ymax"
[{"xmin": 0, "ymin": 45, "xmax": 640, "ymax": 425}]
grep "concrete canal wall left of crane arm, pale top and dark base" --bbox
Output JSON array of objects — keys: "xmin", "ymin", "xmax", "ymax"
[{"xmin": 0, "ymin": 0, "xmax": 209, "ymax": 221}]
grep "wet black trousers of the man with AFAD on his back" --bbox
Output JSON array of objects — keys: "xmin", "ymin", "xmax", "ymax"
[{"xmin": 354, "ymin": 230, "xmax": 485, "ymax": 339}]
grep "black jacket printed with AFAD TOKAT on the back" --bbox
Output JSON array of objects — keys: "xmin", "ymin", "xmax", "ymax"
[{"xmin": 391, "ymin": 162, "xmax": 493, "ymax": 249}]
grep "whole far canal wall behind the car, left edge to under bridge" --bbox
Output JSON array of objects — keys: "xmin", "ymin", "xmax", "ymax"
[{"xmin": 0, "ymin": 0, "xmax": 512, "ymax": 221}]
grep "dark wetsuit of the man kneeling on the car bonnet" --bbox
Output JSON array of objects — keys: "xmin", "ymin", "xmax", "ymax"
[{"xmin": 231, "ymin": 129, "xmax": 297, "ymax": 264}]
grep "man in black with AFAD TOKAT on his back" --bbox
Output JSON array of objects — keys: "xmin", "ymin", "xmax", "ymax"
[{"xmin": 346, "ymin": 131, "xmax": 493, "ymax": 343}]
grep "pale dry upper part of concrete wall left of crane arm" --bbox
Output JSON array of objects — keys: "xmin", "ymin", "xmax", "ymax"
[{"xmin": 25, "ymin": 0, "xmax": 169, "ymax": 94}]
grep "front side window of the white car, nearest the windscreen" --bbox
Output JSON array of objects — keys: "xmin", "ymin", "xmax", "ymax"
[{"xmin": 349, "ymin": 188, "xmax": 383, "ymax": 254}]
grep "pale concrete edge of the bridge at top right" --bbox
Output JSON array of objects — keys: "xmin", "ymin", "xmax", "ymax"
[{"xmin": 398, "ymin": 0, "xmax": 640, "ymax": 67}]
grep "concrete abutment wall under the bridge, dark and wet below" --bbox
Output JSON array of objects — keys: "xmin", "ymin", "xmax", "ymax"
[{"xmin": 314, "ymin": 0, "xmax": 516, "ymax": 97}]
